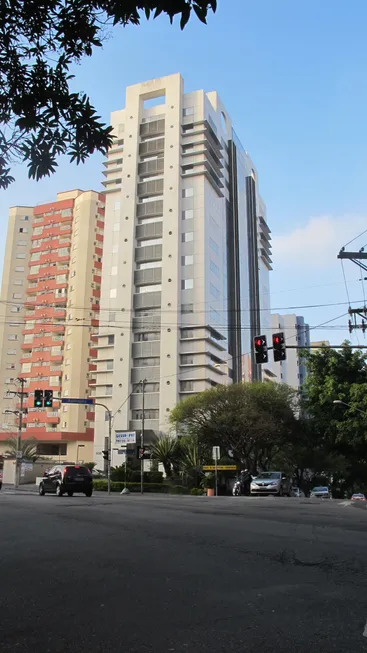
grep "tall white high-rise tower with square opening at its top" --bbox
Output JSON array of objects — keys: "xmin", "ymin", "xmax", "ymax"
[{"xmin": 94, "ymin": 74, "xmax": 271, "ymax": 462}]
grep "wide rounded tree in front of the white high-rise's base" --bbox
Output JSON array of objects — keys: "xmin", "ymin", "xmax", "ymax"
[{"xmin": 170, "ymin": 383, "xmax": 296, "ymax": 472}]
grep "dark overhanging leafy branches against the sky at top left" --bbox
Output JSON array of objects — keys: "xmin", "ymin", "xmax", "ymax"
[{"xmin": 0, "ymin": 0, "xmax": 216, "ymax": 188}]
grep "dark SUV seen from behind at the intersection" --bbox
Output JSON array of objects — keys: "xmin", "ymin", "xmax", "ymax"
[{"xmin": 38, "ymin": 465, "xmax": 93, "ymax": 497}]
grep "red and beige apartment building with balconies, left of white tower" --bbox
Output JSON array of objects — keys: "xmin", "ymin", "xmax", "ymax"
[{"xmin": 0, "ymin": 190, "xmax": 105, "ymax": 462}]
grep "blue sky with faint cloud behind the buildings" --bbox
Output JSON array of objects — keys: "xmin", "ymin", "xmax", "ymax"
[{"xmin": 0, "ymin": 0, "xmax": 367, "ymax": 344}]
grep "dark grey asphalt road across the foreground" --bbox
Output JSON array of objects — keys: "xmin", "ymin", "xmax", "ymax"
[{"xmin": 0, "ymin": 492, "xmax": 367, "ymax": 653}]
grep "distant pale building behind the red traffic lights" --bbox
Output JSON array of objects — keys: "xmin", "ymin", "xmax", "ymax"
[{"xmin": 267, "ymin": 313, "xmax": 310, "ymax": 390}]
